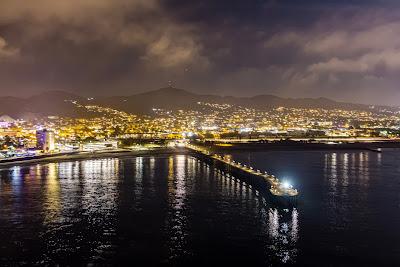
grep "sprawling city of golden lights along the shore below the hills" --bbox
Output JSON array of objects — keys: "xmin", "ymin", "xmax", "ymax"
[{"xmin": 0, "ymin": 100, "xmax": 400, "ymax": 157}]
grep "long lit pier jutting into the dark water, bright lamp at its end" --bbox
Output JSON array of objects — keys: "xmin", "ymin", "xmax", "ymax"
[{"xmin": 186, "ymin": 144, "xmax": 299, "ymax": 203}]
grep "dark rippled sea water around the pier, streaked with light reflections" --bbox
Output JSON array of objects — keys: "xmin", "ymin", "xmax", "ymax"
[{"xmin": 0, "ymin": 151, "xmax": 400, "ymax": 266}]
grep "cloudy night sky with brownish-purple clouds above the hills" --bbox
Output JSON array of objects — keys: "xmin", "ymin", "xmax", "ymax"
[{"xmin": 0, "ymin": 0, "xmax": 400, "ymax": 105}]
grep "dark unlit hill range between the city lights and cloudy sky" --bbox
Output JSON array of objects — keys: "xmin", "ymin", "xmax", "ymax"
[{"xmin": 0, "ymin": 87, "xmax": 386, "ymax": 118}]
